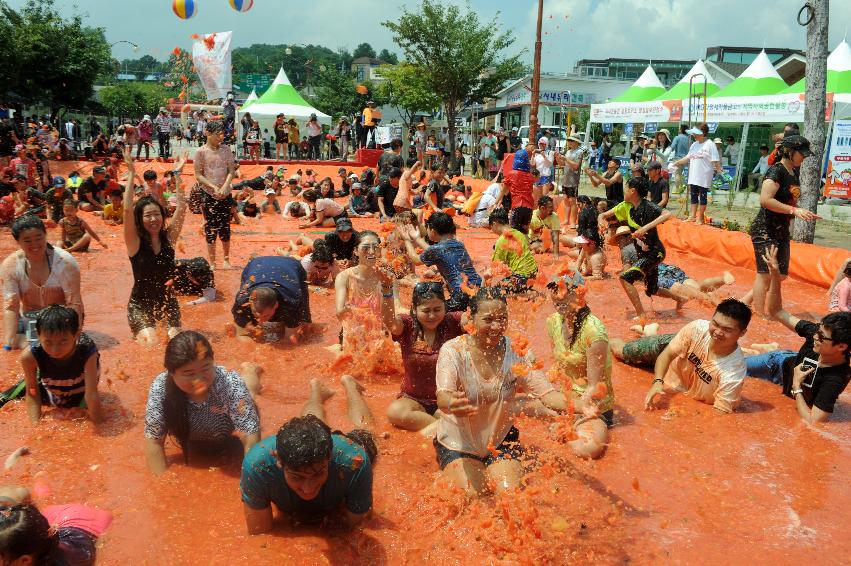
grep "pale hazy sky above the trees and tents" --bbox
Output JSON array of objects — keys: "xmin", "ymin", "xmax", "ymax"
[{"xmin": 6, "ymin": 0, "xmax": 851, "ymax": 72}]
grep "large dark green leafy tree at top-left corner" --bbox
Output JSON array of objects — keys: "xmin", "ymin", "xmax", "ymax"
[{"xmin": 0, "ymin": 0, "xmax": 112, "ymax": 116}]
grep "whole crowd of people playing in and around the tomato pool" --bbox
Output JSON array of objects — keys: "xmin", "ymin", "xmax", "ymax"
[{"xmin": 0, "ymin": 113, "xmax": 851, "ymax": 563}]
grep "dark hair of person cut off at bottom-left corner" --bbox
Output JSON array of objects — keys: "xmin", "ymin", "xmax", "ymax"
[{"xmin": 0, "ymin": 503, "xmax": 59, "ymax": 565}]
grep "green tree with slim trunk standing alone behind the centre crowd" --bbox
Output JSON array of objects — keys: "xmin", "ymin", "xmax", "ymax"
[{"xmin": 382, "ymin": 0, "xmax": 522, "ymax": 161}]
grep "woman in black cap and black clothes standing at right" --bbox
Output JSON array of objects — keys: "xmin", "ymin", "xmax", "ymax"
[{"xmin": 750, "ymin": 136, "xmax": 819, "ymax": 314}]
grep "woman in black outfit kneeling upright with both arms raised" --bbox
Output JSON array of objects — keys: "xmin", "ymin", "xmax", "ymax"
[{"xmin": 124, "ymin": 152, "xmax": 187, "ymax": 346}]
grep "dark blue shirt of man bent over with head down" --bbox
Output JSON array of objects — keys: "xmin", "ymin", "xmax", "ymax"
[{"xmin": 231, "ymin": 256, "xmax": 310, "ymax": 328}]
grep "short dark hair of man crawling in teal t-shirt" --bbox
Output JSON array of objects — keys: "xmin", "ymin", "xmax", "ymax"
[{"xmin": 275, "ymin": 414, "xmax": 334, "ymax": 470}]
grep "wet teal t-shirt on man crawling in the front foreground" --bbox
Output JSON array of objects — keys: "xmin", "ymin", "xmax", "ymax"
[{"xmin": 240, "ymin": 434, "xmax": 372, "ymax": 522}]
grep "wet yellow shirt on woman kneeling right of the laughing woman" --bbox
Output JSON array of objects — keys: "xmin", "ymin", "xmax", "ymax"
[{"xmin": 547, "ymin": 312, "xmax": 615, "ymax": 413}]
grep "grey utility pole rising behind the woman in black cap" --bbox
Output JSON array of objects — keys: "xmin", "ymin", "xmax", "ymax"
[{"xmin": 792, "ymin": 0, "xmax": 830, "ymax": 244}]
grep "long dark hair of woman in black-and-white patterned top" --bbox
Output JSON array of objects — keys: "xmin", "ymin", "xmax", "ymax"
[{"xmin": 163, "ymin": 330, "xmax": 213, "ymax": 464}]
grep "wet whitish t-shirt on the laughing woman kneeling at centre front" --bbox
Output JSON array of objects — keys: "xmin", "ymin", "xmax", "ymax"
[{"xmin": 435, "ymin": 334, "xmax": 555, "ymax": 457}]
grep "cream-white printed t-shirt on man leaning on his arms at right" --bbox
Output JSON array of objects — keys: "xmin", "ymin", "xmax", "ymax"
[{"xmin": 665, "ymin": 320, "xmax": 747, "ymax": 413}]
